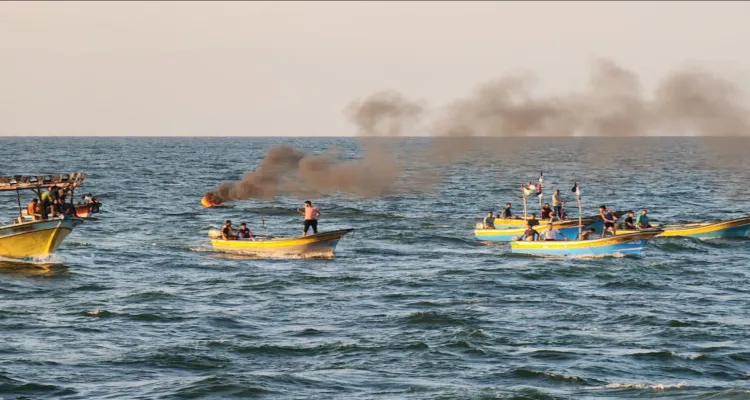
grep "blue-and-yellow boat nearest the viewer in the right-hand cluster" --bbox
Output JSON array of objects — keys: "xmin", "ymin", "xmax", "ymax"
[{"xmin": 510, "ymin": 230, "xmax": 661, "ymax": 257}]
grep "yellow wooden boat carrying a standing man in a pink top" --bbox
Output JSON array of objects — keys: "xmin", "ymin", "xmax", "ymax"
[{"xmin": 209, "ymin": 229, "xmax": 353, "ymax": 258}]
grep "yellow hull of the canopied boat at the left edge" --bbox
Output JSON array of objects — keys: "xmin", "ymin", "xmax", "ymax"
[{"xmin": 0, "ymin": 217, "xmax": 83, "ymax": 259}]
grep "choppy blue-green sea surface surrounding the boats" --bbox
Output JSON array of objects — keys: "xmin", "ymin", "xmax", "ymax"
[{"xmin": 0, "ymin": 138, "xmax": 750, "ymax": 399}]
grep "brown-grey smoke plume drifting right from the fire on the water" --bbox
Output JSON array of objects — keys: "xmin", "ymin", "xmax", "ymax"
[{"xmin": 206, "ymin": 60, "xmax": 750, "ymax": 203}]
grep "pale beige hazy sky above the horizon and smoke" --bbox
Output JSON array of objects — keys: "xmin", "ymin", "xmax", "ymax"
[{"xmin": 0, "ymin": 1, "xmax": 750, "ymax": 136}]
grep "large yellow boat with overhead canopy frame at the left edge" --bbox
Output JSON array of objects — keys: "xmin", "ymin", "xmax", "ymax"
[{"xmin": 0, "ymin": 173, "xmax": 86, "ymax": 259}]
